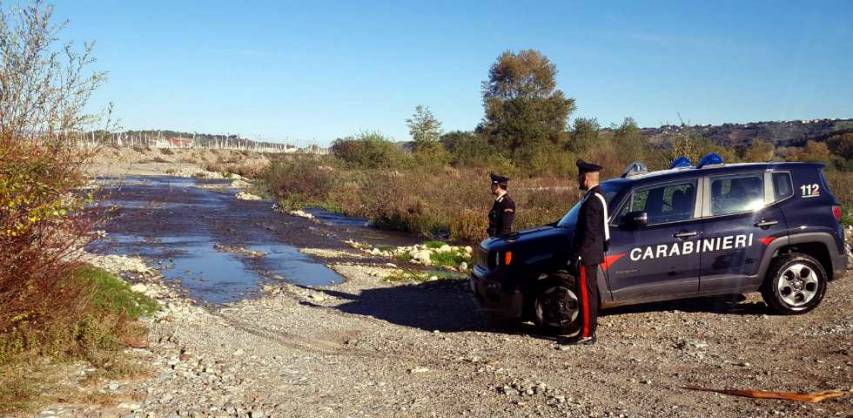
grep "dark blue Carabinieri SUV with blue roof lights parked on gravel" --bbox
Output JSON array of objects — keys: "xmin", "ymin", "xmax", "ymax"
[{"xmin": 471, "ymin": 154, "xmax": 847, "ymax": 333}]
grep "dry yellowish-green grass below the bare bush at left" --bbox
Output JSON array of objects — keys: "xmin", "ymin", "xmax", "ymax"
[{"xmin": 0, "ymin": 266, "xmax": 157, "ymax": 413}]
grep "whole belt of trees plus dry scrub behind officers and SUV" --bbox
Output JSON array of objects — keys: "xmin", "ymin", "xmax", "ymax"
[{"xmin": 261, "ymin": 50, "xmax": 853, "ymax": 241}]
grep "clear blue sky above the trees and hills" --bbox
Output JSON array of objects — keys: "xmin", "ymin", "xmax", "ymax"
[{"xmin": 55, "ymin": 0, "xmax": 853, "ymax": 145}]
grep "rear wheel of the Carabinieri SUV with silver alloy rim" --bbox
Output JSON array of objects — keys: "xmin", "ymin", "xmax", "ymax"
[{"xmin": 761, "ymin": 253, "xmax": 828, "ymax": 315}]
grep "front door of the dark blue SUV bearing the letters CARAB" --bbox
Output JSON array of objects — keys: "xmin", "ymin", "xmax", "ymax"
[{"xmin": 603, "ymin": 178, "xmax": 702, "ymax": 304}]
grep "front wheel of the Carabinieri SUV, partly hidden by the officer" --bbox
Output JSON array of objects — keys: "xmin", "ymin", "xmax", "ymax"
[{"xmin": 531, "ymin": 277, "xmax": 581, "ymax": 335}]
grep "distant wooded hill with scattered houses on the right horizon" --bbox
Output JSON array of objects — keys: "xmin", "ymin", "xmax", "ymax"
[{"xmin": 641, "ymin": 119, "xmax": 853, "ymax": 148}]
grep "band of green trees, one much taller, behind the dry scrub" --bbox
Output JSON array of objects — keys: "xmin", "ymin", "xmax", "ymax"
[{"xmin": 331, "ymin": 50, "xmax": 853, "ymax": 177}]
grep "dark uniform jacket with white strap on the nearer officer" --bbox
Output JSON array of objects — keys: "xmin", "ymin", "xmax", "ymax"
[{"xmin": 574, "ymin": 186, "xmax": 610, "ymax": 266}]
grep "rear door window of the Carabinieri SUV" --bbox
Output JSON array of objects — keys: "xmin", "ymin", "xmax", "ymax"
[{"xmin": 711, "ymin": 174, "xmax": 764, "ymax": 216}]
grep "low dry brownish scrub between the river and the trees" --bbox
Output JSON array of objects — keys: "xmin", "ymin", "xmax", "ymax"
[{"xmin": 262, "ymin": 158, "xmax": 578, "ymax": 242}]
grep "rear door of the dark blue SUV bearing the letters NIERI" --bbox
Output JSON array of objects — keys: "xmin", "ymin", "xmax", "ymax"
[{"xmin": 699, "ymin": 171, "xmax": 793, "ymax": 294}]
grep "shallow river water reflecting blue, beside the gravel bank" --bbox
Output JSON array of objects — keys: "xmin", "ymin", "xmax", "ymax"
[{"xmin": 89, "ymin": 176, "xmax": 412, "ymax": 304}]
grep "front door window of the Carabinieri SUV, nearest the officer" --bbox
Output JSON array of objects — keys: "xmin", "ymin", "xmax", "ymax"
[{"xmin": 619, "ymin": 179, "xmax": 696, "ymax": 225}]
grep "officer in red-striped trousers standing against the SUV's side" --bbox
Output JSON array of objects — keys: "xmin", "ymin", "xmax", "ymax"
[{"xmin": 573, "ymin": 160, "xmax": 610, "ymax": 344}]
